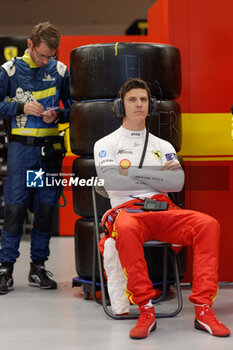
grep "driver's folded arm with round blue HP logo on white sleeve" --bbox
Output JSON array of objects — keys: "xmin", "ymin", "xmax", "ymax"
[{"xmin": 94, "ymin": 140, "xmax": 152, "ymax": 196}]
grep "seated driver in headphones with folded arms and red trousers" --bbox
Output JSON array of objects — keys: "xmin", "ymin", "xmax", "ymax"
[{"xmin": 94, "ymin": 78, "xmax": 230, "ymax": 339}]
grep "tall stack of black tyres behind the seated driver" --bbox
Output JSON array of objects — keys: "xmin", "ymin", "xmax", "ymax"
[{"xmin": 70, "ymin": 43, "xmax": 186, "ymax": 296}]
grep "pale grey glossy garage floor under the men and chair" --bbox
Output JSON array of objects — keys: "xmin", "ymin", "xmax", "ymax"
[{"xmin": 0, "ymin": 237, "xmax": 233, "ymax": 350}]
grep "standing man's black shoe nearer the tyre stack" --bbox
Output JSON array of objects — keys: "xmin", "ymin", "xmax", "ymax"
[{"xmin": 28, "ymin": 262, "xmax": 57, "ymax": 289}]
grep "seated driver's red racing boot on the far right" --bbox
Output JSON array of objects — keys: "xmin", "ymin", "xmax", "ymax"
[{"xmin": 194, "ymin": 304, "xmax": 231, "ymax": 337}]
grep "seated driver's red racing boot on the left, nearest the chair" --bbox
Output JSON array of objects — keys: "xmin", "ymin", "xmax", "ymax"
[{"xmin": 129, "ymin": 306, "xmax": 156, "ymax": 339}]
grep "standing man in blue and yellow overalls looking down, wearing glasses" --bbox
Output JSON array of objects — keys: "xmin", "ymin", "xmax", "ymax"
[{"xmin": 0, "ymin": 22, "xmax": 72, "ymax": 294}]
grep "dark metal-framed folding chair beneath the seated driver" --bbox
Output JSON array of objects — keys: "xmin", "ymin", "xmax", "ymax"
[{"xmin": 92, "ymin": 186, "xmax": 183, "ymax": 319}]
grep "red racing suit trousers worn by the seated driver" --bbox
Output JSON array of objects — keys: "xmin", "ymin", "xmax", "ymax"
[{"xmin": 104, "ymin": 195, "xmax": 220, "ymax": 306}]
